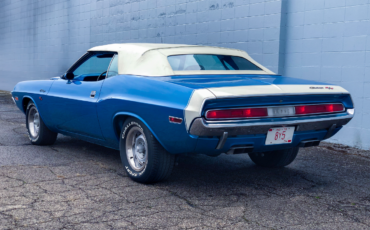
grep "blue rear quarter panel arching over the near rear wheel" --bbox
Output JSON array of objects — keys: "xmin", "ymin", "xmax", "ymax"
[{"xmin": 97, "ymin": 75, "xmax": 197, "ymax": 154}]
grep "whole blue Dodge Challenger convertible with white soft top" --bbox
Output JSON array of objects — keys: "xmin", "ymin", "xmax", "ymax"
[{"xmin": 12, "ymin": 44, "xmax": 354, "ymax": 183}]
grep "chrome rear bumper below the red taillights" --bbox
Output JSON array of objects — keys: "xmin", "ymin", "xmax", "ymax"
[{"xmin": 189, "ymin": 109, "xmax": 354, "ymax": 137}]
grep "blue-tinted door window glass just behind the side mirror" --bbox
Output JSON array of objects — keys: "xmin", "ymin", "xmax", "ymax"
[{"xmin": 73, "ymin": 54, "xmax": 113, "ymax": 78}]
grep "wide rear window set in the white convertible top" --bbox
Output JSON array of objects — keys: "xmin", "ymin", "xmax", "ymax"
[{"xmin": 167, "ymin": 54, "xmax": 262, "ymax": 71}]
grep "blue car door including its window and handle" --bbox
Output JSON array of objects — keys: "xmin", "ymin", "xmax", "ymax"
[{"xmin": 47, "ymin": 52, "xmax": 114, "ymax": 139}]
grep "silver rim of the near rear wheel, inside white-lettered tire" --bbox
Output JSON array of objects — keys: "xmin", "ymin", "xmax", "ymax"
[{"xmin": 126, "ymin": 127, "xmax": 148, "ymax": 172}]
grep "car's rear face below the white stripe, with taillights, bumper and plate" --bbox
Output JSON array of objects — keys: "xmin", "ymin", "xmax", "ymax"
[{"xmin": 189, "ymin": 89, "xmax": 354, "ymax": 154}]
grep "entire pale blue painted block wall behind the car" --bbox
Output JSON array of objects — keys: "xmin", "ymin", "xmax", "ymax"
[{"xmin": 0, "ymin": 0, "xmax": 370, "ymax": 149}]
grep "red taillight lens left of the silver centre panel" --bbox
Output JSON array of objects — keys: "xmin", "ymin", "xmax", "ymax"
[{"xmin": 206, "ymin": 108, "xmax": 268, "ymax": 119}]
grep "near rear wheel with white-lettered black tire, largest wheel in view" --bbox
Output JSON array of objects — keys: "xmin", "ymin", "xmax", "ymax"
[{"xmin": 120, "ymin": 118, "xmax": 175, "ymax": 184}]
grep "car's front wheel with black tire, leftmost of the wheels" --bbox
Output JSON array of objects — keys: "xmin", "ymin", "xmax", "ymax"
[{"xmin": 26, "ymin": 101, "xmax": 58, "ymax": 145}]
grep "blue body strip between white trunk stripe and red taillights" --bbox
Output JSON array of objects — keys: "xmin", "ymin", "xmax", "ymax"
[{"xmin": 202, "ymin": 94, "xmax": 353, "ymax": 116}]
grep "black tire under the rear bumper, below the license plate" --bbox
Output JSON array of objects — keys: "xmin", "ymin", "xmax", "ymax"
[{"xmin": 249, "ymin": 147, "xmax": 299, "ymax": 168}]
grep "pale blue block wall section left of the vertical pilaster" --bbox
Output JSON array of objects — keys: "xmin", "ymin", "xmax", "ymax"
[{"xmin": 0, "ymin": 0, "xmax": 281, "ymax": 90}]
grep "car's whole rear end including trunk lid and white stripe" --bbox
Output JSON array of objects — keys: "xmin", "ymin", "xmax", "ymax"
[{"xmin": 165, "ymin": 75, "xmax": 354, "ymax": 155}]
